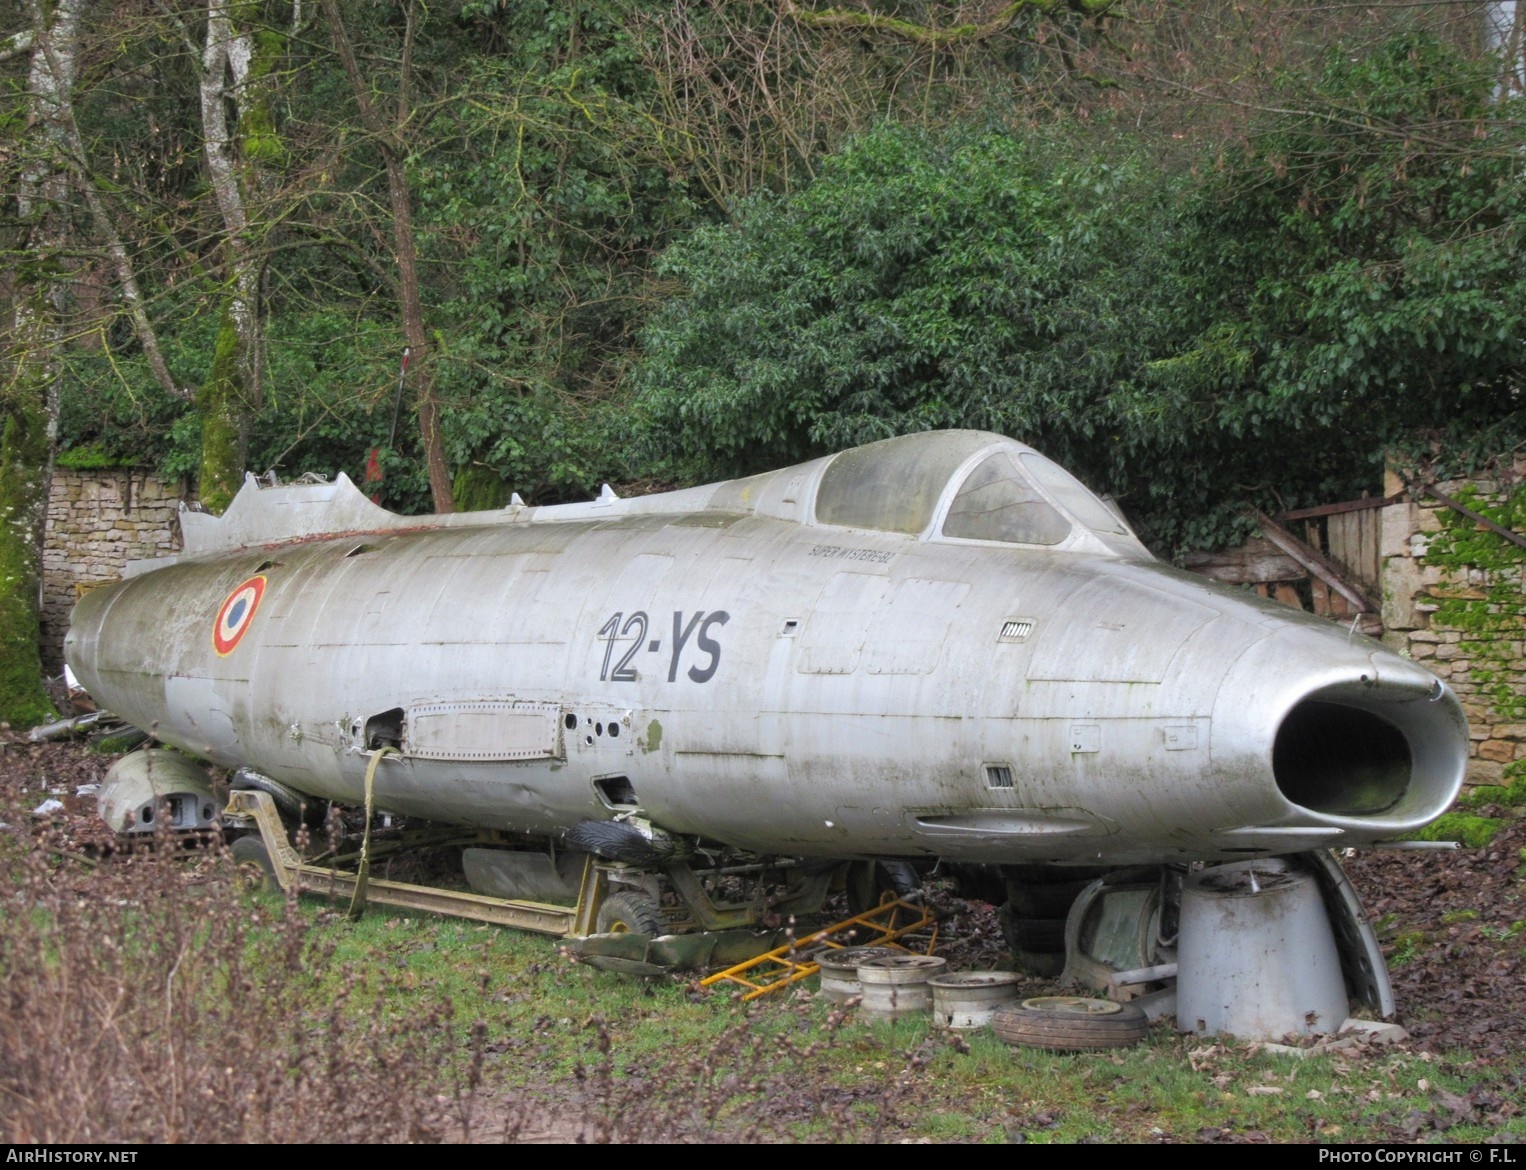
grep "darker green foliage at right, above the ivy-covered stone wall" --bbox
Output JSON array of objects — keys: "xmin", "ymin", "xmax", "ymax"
[{"xmin": 1157, "ymin": 32, "xmax": 1526, "ymax": 482}]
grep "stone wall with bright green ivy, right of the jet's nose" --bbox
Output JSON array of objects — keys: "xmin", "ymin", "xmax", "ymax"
[{"xmin": 1380, "ymin": 458, "xmax": 1526, "ymax": 784}]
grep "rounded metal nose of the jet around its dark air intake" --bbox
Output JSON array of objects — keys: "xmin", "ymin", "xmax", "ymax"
[{"xmin": 1213, "ymin": 625, "xmax": 1468, "ymax": 848}]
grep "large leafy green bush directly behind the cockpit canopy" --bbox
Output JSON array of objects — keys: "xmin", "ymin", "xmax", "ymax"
[{"xmin": 635, "ymin": 125, "xmax": 1186, "ymax": 540}]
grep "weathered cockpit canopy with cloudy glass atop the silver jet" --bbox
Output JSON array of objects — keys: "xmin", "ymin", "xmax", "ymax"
[{"xmin": 815, "ymin": 430, "xmax": 1137, "ymax": 548}]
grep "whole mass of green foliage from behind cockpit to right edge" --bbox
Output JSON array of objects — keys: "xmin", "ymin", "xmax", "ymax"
[{"xmin": 633, "ymin": 32, "xmax": 1526, "ymax": 552}]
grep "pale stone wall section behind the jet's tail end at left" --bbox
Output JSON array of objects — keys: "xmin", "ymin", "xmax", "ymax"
[{"xmin": 43, "ymin": 468, "xmax": 188, "ymax": 674}]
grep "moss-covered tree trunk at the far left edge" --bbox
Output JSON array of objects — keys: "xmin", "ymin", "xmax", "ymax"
[{"xmin": 0, "ymin": 0, "xmax": 89, "ymax": 726}]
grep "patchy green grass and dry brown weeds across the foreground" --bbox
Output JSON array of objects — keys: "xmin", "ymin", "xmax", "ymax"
[{"xmin": 0, "ymin": 818, "xmax": 1526, "ymax": 1144}]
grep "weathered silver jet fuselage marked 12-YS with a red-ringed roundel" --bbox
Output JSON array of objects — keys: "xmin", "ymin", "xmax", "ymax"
[{"xmin": 69, "ymin": 433, "xmax": 1466, "ymax": 865}]
